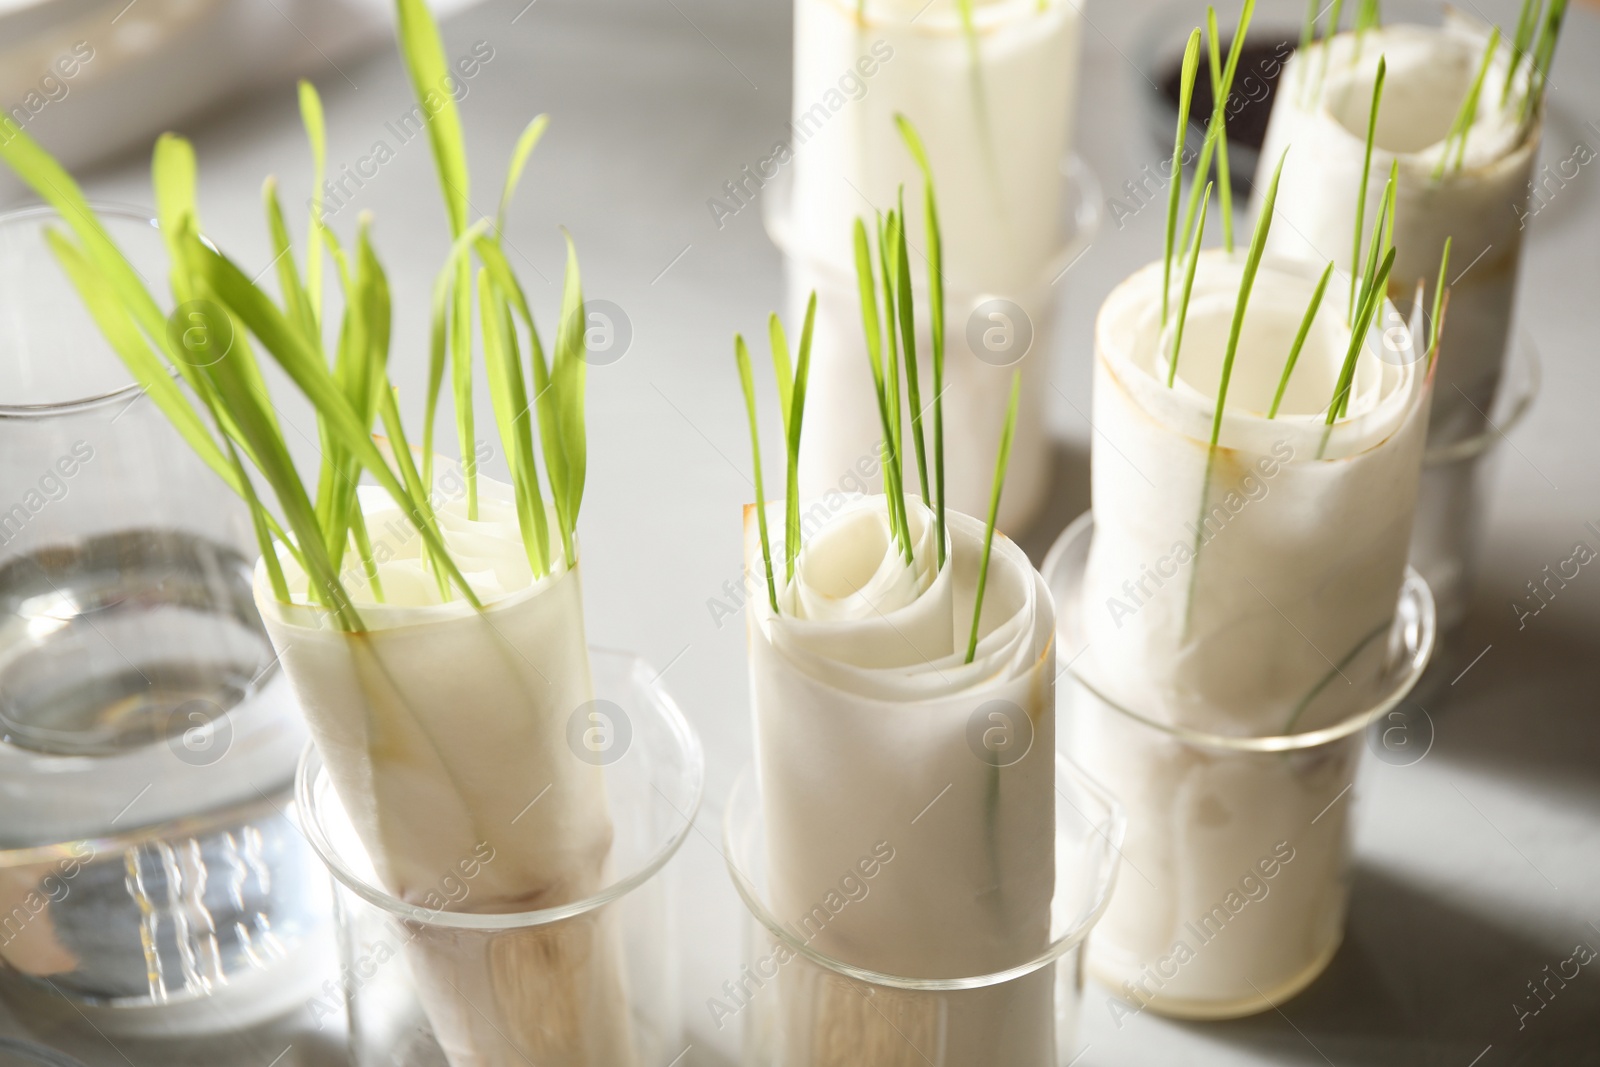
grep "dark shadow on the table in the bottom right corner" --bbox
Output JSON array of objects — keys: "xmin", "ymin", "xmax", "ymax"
[{"xmin": 1203, "ymin": 867, "xmax": 1600, "ymax": 1067}]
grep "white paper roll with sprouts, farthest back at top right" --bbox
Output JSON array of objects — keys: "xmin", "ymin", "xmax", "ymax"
[{"xmin": 1262, "ymin": 14, "xmax": 1544, "ymax": 443}]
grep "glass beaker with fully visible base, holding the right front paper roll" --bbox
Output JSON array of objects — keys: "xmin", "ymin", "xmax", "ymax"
[{"xmin": 1042, "ymin": 512, "xmax": 1435, "ymax": 1024}]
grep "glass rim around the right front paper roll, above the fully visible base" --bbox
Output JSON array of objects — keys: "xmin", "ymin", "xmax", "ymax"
[{"xmin": 1038, "ymin": 509, "xmax": 1438, "ymax": 753}]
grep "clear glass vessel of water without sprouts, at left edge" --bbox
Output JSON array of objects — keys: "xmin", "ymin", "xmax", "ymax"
[{"xmin": 0, "ymin": 206, "xmax": 331, "ymax": 1033}]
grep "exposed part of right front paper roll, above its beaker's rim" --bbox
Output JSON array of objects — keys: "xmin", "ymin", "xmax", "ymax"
[{"xmin": 1082, "ymin": 251, "xmax": 1430, "ymax": 736}]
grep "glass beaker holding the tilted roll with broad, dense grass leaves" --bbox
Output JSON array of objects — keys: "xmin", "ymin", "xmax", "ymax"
[{"xmin": 296, "ymin": 649, "xmax": 704, "ymax": 1067}]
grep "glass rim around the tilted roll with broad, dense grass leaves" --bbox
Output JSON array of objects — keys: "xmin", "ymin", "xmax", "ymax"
[{"xmin": 294, "ymin": 646, "xmax": 706, "ymax": 933}]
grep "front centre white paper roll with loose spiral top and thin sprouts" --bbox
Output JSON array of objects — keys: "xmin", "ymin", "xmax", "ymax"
[{"xmin": 746, "ymin": 496, "xmax": 1058, "ymax": 1067}]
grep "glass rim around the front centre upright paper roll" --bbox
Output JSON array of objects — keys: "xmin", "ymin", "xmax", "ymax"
[{"xmin": 722, "ymin": 752, "xmax": 1128, "ymax": 993}]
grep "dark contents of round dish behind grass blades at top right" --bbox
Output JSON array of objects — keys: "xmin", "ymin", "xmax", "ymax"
[{"xmin": 1146, "ymin": 35, "xmax": 1296, "ymax": 191}]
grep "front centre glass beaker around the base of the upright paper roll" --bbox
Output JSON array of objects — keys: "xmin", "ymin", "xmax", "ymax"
[{"xmin": 726, "ymin": 757, "xmax": 1123, "ymax": 1067}]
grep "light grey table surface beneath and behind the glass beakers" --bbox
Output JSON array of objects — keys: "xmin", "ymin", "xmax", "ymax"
[{"xmin": 3, "ymin": 0, "xmax": 1600, "ymax": 1067}]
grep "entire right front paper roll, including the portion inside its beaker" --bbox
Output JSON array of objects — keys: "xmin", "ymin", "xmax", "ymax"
[{"xmin": 1069, "ymin": 247, "xmax": 1430, "ymax": 1017}]
